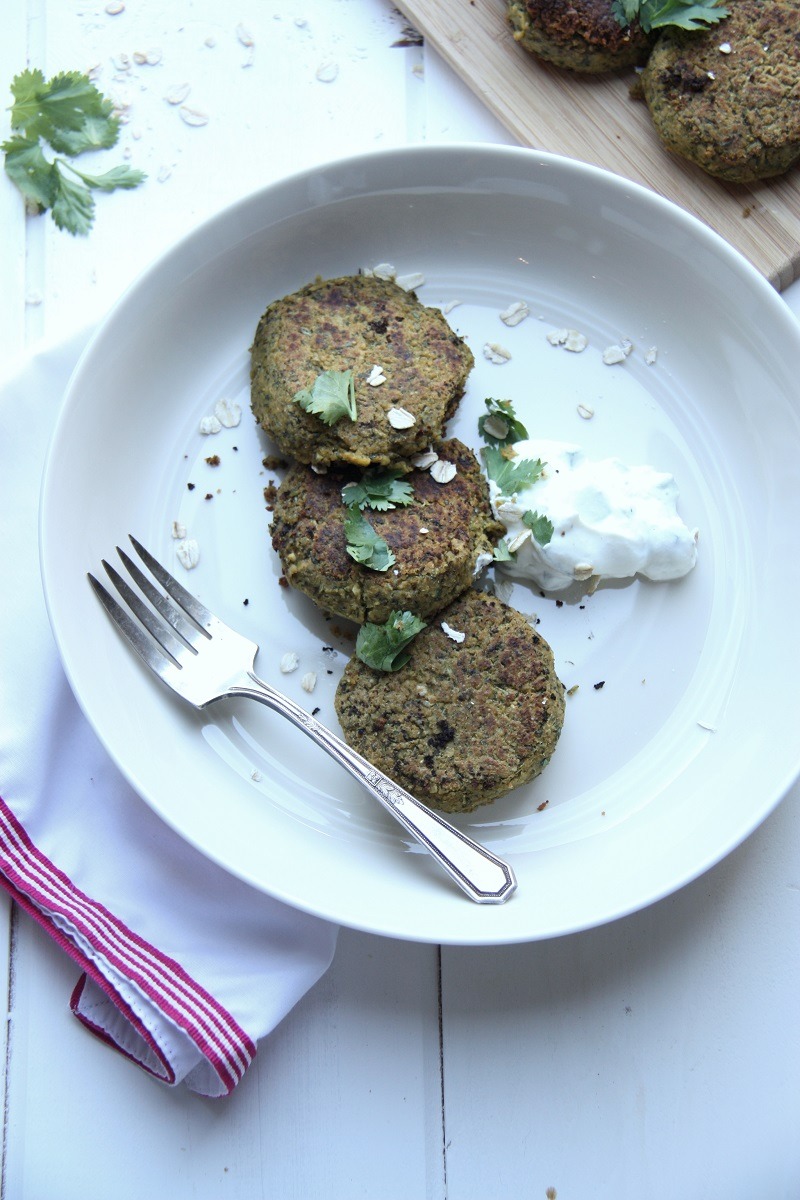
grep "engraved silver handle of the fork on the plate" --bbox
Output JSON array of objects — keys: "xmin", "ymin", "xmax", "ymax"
[{"xmin": 225, "ymin": 671, "xmax": 517, "ymax": 904}]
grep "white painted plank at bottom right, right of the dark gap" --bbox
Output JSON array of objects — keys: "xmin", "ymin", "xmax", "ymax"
[{"xmin": 443, "ymin": 788, "xmax": 800, "ymax": 1200}]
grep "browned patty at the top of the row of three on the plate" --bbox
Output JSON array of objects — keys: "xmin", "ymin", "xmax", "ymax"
[{"xmin": 251, "ymin": 275, "xmax": 474, "ymax": 467}]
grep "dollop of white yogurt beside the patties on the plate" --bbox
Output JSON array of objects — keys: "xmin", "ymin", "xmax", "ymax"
[{"xmin": 489, "ymin": 439, "xmax": 698, "ymax": 592}]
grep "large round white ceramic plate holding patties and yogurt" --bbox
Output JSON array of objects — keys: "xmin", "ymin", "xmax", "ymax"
[{"xmin": 41, "ymin": 146, "xmax": 800, "ymax": 944}]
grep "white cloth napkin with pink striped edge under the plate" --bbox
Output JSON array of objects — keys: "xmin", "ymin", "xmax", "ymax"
[{"xmin": 0, "ymin": 335, "xmax": 336, "ymax": 1096}]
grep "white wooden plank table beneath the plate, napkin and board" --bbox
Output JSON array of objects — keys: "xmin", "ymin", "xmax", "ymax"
[{"xmin": 0, "ymin": 0, "xmax": 800, "ymax": 1200}]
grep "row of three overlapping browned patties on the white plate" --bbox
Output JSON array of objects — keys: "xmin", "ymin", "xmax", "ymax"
[{"xmin": 251, "ymin": 274, "xmax": 564, "ymax": 812}]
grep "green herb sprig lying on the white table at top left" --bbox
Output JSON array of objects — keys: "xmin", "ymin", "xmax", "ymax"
[{"xmin": 0, "ymin": 70, "xmax": 146, "ymax": 236}]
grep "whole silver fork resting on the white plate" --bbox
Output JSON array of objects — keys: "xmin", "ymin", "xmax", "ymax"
[{"xmin": 89, "ymin": 535, "xmax": 517, "ymax": 904}]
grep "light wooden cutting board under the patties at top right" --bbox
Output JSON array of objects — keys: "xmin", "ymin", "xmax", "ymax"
[{"xmin": 397, "ymin": 0, "xmax": 800, "ymax": 290}]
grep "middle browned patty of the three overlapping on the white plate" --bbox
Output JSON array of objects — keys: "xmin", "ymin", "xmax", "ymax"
[{"xmin": 272, "ymin": 438, "xmax": 503, "ymax": 624}]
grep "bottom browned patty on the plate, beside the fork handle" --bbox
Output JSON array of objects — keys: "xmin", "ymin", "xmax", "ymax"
[{"xmin": 336, "ymin": 589, "xmax": 564, "ymax": 812}]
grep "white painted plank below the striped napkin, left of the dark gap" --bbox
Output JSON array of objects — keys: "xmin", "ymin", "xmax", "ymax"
[{"xmin": 4, "ymin": 916, "xmax": 444, "ymax": 1200}]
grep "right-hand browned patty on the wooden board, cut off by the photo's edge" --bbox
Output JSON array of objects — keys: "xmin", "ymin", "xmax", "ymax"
[{"xmin": 642, "ymin": 0, "xmax": 800, "ymax": 182}]
